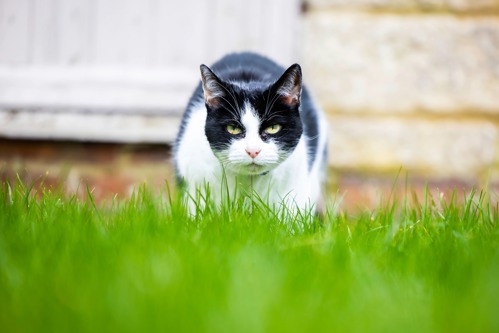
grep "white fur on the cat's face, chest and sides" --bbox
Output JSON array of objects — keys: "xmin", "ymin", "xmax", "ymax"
[{"xmin": 176, "ymin": 101, "xmax": 326, "ymax": 213}]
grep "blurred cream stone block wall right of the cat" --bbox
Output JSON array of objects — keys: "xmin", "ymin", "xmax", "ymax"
[{"xmin": 303, "ymin": 0, "xmax": 499, "ymax": 195}]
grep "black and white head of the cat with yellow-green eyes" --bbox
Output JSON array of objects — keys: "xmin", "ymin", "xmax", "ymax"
[{"xmin": 201, "ymin": 64, "xmax": 303, "ymax": 175}]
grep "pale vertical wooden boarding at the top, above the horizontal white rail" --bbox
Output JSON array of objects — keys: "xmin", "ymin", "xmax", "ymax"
[{"xmin": 0, "ymin": 0, "xmax": 300, "ymax": 66}]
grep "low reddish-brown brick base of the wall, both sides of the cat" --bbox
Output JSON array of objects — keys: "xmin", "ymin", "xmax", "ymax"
[{"xmin": 0, "ymin": 140, "xmax": 490, "ymax": 210}]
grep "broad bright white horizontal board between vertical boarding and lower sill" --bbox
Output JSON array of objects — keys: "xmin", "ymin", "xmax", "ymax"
[{"xmin": 0, "ymin": 66, "xmax": 199, "ymax": 111}]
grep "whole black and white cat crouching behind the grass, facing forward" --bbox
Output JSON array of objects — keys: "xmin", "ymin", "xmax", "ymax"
[{"xmin": 174, "ymin": 53, "xmax": 327, "ymax": 211}]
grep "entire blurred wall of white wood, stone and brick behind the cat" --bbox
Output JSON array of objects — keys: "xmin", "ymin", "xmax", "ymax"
[{"xmin": 0, "ymin": 0, "xmax": 499, "ymax": 208}]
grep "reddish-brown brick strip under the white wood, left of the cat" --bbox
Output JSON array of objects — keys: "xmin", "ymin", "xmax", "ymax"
[{"xmin": 0, "ymin": 139, "xmax": 174, "ymax": 202}]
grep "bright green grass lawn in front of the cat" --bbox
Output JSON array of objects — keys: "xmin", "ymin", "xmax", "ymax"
[{"xmin": 0, "ymin": 182, "xmax": 499, "ymax": 332}]
